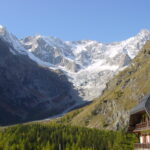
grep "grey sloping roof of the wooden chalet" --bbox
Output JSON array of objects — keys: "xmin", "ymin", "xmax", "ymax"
[{"xmin": 130, "ymin": 93, "xmax": 150, "ymax": 116}]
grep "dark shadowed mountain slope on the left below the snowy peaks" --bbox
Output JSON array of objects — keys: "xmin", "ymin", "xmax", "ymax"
[{"xmin": 0, "ymin": 36, "xmax": 79, "ymax": 125}]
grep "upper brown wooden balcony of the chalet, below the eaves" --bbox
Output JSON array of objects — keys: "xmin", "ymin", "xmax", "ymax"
[{"xmin": 134, "ymin": 121, "xmax": 150, "ymax": 132}]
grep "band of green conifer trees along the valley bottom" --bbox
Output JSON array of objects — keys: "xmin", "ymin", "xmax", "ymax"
[{"xmin": 0, "ymin": 123, "xmax": 136, "ymax": 150}]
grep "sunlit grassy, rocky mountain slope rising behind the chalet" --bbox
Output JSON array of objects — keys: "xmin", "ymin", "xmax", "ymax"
[{"xmin": 58, "ymin": 41, "xmax": 150, "ymax": 130}]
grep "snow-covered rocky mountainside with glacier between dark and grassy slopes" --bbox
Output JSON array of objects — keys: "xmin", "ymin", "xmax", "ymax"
[{"xmin": 21, "ymin": 30, "xmax": 150, "ymax": 100}]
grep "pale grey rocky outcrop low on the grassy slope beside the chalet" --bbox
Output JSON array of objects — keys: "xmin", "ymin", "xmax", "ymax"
[{"xmin": 93, "ymin": 100, "xmax": 130, "ymax": 130}]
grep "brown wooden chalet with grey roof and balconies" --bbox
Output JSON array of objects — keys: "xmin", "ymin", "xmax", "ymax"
[{"xmin": 128, "ymin": 93, "xmax": 150, "ymax": 150}]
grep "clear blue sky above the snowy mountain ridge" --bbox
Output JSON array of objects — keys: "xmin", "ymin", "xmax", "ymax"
[{"xmin": 0, "ymin": 0, "xmax": 150, "ymax": 42}]
